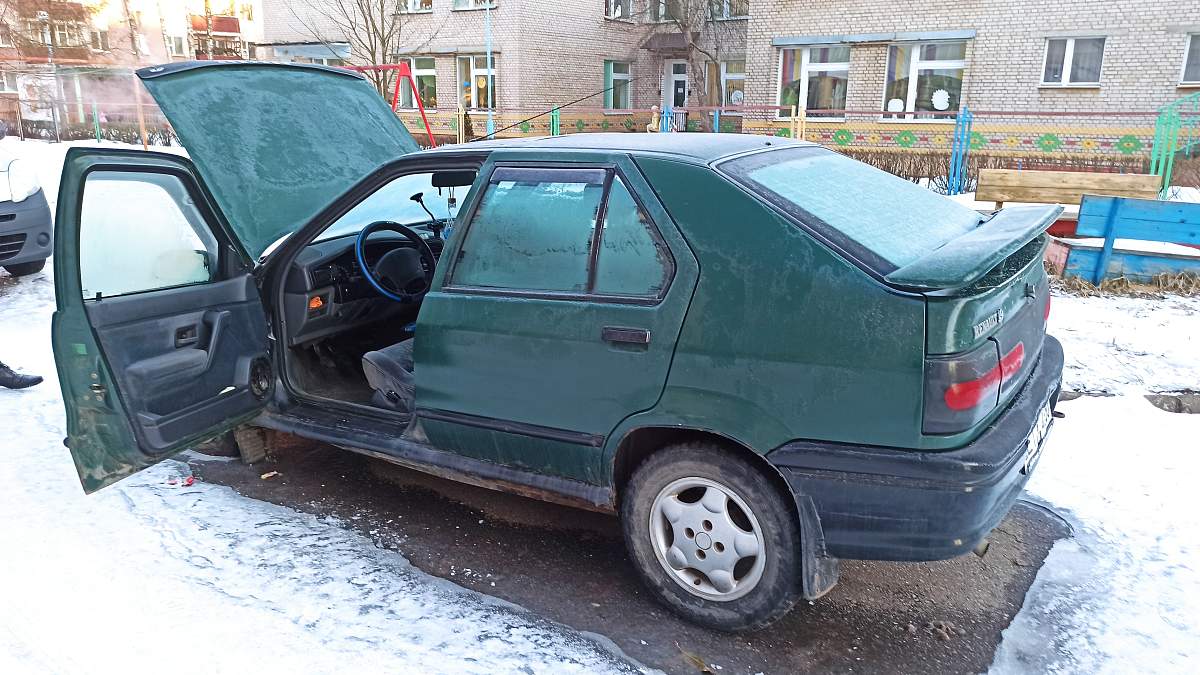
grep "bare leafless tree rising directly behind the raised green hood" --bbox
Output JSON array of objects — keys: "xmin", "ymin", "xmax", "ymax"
[{"xmin": 290, "ymin": 0, "xmax": 444, "ymax": 97}]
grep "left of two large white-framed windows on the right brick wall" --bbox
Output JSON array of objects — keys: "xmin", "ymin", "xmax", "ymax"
[{"xmin": 779, "ymin": 44, "xmax": 850, "ymax": 117}]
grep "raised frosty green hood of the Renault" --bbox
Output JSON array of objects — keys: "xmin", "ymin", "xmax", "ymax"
[{"xmin": 138, "ymin": 61, "xmax": 420, "ymax": 258}]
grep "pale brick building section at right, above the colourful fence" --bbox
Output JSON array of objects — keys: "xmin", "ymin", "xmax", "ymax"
[{"xmin": 746, "ymin": 0, "xmax": 1200, "ymax": 119}]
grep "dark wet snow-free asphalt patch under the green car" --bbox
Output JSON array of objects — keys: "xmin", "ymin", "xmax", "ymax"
[{"xmin": 188, "ymin": 432, "xmax": 1069, "ymax": 675}]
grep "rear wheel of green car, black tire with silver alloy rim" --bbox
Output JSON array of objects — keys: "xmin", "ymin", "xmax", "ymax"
[{"xmin": 620, "ymin": 443, "xmax": 802, "ymax": 631}]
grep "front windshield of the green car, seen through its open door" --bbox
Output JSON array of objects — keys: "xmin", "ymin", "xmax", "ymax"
[{"xmin": 316, "ymin": 173, "xmax": 468, "ymax": 241}]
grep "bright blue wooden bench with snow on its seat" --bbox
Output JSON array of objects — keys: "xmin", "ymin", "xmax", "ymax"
[{"xmin": 1050, "ymin": 195, "xmax": 1200, "ymax": 285}]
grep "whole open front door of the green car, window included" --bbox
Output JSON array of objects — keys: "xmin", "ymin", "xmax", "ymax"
[{"xmin": 53, "ymin": 148, "xmax": 274, "ymax": 492}]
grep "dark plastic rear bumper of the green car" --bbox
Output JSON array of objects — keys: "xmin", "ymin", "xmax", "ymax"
[{"xmin": 767, "ymin": 335, "xmax": 1063, "ymax": 561}]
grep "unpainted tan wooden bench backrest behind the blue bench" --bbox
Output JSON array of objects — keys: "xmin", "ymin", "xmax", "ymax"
[{"xmin": 976, "ymin": 169, "xmax": 1162, "ymax": 209}]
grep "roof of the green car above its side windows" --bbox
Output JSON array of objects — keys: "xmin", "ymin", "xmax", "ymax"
[{"xmin": 417, "ymin": 133, "xmax": 817, "ymax": 165}]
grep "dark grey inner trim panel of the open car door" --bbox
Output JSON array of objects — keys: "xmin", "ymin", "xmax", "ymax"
[{"xmin": 84, "ymin": 274, "xmax": 266, "ymax": 452}]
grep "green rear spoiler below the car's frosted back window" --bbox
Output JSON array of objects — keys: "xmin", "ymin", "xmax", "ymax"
[{"xmin": 883, "ymin": 205, "xmax": 1062, "ymax": 289}]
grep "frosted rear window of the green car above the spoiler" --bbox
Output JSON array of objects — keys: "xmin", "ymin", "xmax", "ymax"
[{"xmin": 718, "ymin": 148, "xmax": 982, "ymax": 274}]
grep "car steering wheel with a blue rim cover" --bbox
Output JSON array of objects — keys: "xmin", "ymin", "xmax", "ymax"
[{"xmin": 354, "ymin": 220, "xmax": 438, "ymax": 305}]
